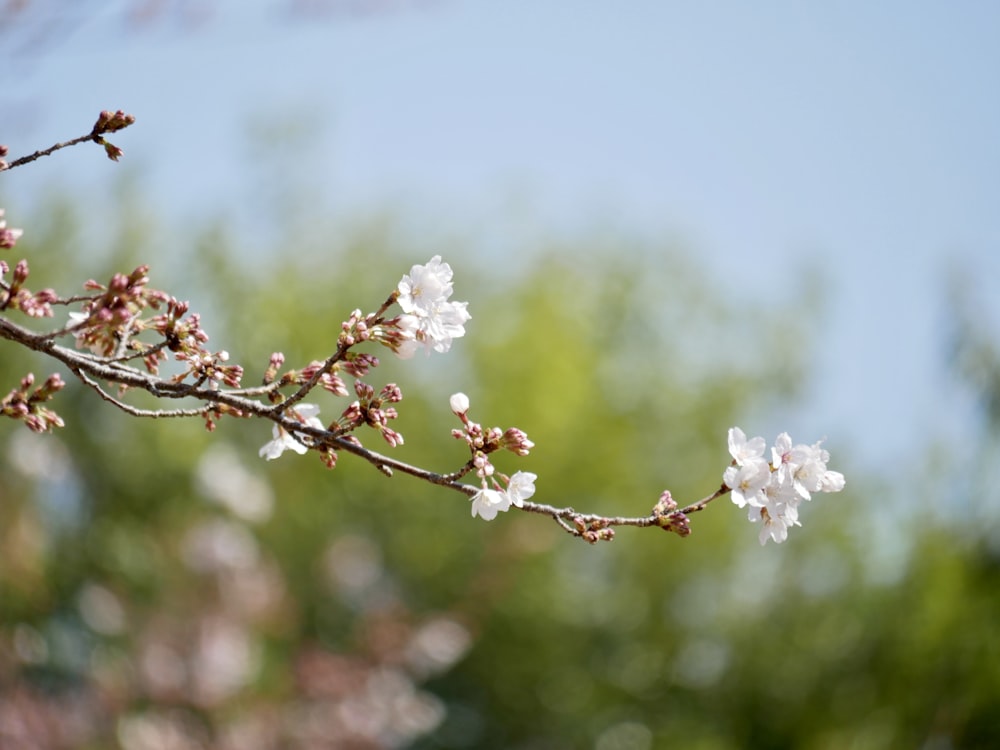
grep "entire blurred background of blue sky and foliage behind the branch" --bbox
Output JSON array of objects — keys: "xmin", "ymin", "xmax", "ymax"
[{"xmin": 0, "ymin": 0, "xmax": 1000, "ymax": 750}]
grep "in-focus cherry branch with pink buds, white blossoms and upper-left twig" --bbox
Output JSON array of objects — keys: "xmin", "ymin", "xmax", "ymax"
[{"xmin": 0, "ymin": 110, "xmax": 844, "ymax": 544}]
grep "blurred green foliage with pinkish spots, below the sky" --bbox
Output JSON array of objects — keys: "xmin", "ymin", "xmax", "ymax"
[{"xmin": 0, "ymin": 196, "xmax": 1000, "ymax": 750}]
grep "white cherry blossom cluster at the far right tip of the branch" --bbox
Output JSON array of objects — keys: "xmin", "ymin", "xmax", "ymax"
[{"xmin": 722, "ymin": 427, "xmax": 845, "ymax": 544}]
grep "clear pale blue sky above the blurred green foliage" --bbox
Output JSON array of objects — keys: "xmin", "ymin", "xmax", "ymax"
[{"xmin": 0, "ymin": 0, "xmax": 1000, "ymax": 476}]
